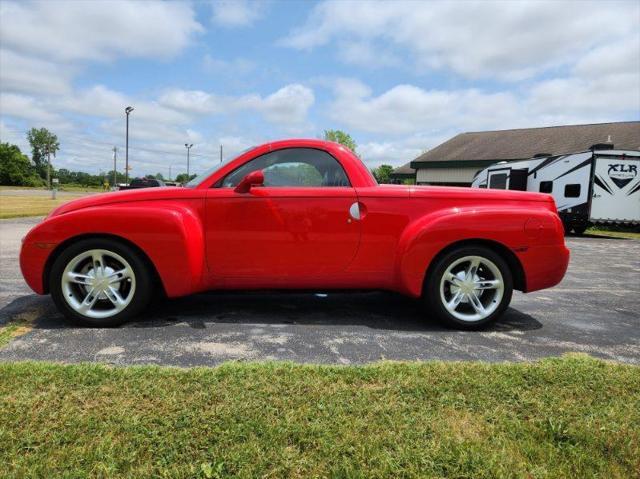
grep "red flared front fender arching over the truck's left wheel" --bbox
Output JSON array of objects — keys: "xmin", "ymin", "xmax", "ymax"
[{"xmin": 20, "ymin": 200, "xmax": 205, "ymax": 297}]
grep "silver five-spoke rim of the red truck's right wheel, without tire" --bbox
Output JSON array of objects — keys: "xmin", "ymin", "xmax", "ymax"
[{"xmin": 440, "ymin": 256, "xmax": 504, "ymax": 322}]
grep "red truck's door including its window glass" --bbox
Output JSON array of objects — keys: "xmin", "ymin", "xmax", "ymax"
[{"xmin": 205, "ymin": 148, "xmax": 360, "ymax": 286}]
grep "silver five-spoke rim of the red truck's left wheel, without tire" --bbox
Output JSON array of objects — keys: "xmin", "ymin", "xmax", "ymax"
[{"xmin": 61, "ymin": 249, "xmax": 136, "ymax": 319}]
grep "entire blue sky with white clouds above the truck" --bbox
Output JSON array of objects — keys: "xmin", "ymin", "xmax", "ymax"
[{"xmin": 0, "ymin": 0, "xmax": 640, "ymax": 175}]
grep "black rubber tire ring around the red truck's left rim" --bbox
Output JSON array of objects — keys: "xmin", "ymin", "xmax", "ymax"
[{"xmin": 49, "ymin": 238, "xmax": 153, "ymax": 327}]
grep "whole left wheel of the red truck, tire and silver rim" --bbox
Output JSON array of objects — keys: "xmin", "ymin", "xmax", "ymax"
[{"xmin": 49, "ymin": 239, "xmax": 152, "ymax": 327}]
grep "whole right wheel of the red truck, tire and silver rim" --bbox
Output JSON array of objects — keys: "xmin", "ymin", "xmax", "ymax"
[{"xmin": 424, "ymin": 246, "xmax": 513, "ymax": 329}]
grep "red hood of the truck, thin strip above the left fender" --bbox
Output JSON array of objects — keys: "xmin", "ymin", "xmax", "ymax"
[{"xmin": 49, "ymin": 186, "xmax": 202, "ymax": 217}]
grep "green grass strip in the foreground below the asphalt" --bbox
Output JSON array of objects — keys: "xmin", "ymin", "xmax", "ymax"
[{"xmin": 0, "ymin": 356, "xmax": 640, "ymax": 478}]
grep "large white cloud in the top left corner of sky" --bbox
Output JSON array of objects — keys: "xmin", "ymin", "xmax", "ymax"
[{"xmin": 0, "ymin": 0, "xmax": 203, "ymax": 61}]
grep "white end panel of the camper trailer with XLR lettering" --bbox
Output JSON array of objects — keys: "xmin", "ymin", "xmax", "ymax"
[{"xmin": 589, "ymin": 157, "xmax": 640, "ymax": 223}]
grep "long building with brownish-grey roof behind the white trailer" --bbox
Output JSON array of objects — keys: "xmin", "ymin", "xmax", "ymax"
[{"xmin": 392, "ymin": 121, "xmax": 640, "ymax": 186}]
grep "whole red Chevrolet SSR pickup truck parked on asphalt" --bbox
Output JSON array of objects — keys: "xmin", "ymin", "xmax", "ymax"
[{"xmin": 20, "ymin": 140, "xmax": 569, "ymax": 329}]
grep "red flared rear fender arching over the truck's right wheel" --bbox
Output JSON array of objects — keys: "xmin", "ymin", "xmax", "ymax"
[{"xmin": 395, "ymin": 206, "xmax": 558, "ymax": 297}]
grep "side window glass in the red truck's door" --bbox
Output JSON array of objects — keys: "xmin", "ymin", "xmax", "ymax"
[{"xmin": 222, "ymin": 148, "xmax": 350, "ymax": 188}]
